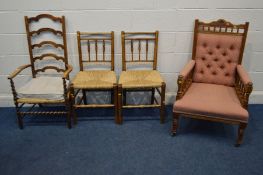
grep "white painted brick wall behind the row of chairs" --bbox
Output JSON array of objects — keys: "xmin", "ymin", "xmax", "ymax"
[{"xmin": 0, "ymin": 0, "xmax": 263, "ymax": 106}]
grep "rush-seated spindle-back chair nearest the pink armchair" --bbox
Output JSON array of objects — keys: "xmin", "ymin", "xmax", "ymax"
[{"xmin": 118, "ymin": 31, "xmax": 166, "ymax": 124}]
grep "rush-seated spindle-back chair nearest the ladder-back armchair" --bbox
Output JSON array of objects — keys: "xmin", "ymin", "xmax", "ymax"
[{"xmin": 71, "ymin": 31, "xmax": 118, "ymax": 124}]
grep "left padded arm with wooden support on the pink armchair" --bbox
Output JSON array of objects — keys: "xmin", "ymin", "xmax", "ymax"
[{"xmin": 176, "ymin": 60, "xmax": 195, "ymax": 100}]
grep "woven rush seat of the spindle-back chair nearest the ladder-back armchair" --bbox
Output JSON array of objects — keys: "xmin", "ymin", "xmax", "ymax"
[{"xmin": 72, "ymin": 70, "xmax": 117, "ymax": 89}]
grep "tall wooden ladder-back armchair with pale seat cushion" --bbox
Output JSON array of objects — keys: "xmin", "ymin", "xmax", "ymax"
[{"xmin": 8, "ymin": 14, "xmax": 72, "ymax": 129}]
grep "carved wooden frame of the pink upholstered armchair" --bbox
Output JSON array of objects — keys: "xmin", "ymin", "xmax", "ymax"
[{"xmin": 171, "ymin": 19, "xmax": 253, "ymax": 146}]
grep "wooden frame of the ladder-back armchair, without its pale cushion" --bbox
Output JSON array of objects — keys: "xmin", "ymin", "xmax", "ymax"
[{"xmin": 8, "ymin": 14, "xmax": 72, "ymax": 129}]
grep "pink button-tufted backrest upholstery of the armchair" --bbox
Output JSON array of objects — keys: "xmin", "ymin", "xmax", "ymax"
[{"xmin": 193, "ymin": 33, "xmax": 242, "ymax": 86}]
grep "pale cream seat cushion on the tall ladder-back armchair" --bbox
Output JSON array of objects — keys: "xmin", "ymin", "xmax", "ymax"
[{"xmin": 17, "ymin": 77, "xmax": 68, "ymax": 102}]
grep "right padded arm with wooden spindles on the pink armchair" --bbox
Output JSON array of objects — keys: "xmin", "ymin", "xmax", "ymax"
[{"xmin": 235, "ymin": 65, "xmax": 253, "ymax": 109}]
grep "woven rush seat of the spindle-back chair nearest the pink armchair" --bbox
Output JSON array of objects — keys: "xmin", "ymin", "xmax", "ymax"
[{"xmin": 119, "ymin": 70, "xmax": 164, "ymax": 89}]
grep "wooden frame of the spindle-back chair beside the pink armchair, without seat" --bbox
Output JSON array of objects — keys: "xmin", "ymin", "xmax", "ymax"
[{"xmin": 118, "ymin": 31, "xmax": 166, "ymax": 124}]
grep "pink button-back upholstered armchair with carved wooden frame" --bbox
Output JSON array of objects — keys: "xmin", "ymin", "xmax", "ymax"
[{"xmin": 172, "ymin": 19, "xmax": 252, "ymax": 146}]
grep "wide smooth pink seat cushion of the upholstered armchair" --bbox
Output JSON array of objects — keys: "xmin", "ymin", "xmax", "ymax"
[{"xmin": 173, "ymin": 83, "xmax": 248, "ymax": 121}]
